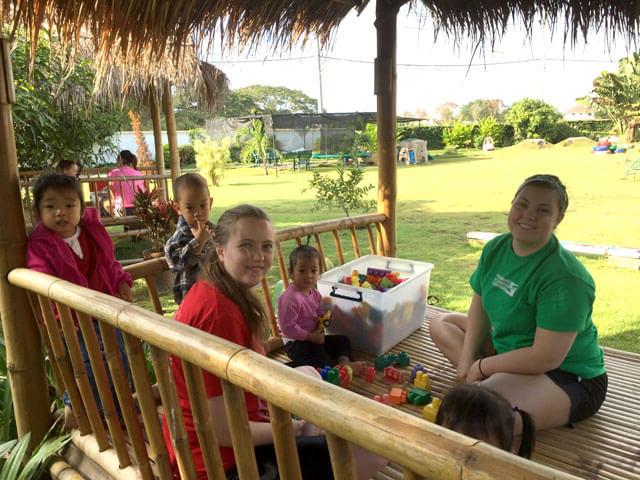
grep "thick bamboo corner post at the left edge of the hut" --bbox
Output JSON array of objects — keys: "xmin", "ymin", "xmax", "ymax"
[{"xmin": 0, "ymin": 34, "xmax": 51, "ymax": 449}]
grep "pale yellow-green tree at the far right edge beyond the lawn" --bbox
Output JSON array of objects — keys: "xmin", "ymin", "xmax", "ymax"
[{"xmin": 582, "ymin": 52, "xmax": 640, "ymax": 136}]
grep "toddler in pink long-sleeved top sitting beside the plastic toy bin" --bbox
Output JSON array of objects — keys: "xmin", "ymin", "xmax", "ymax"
[{"xmin": 278, "ymin": 245, "xmax": 364, "ymax": 373}]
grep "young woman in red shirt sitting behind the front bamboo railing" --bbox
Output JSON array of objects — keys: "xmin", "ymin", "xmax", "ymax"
[{"xmin": 163, "ymin": 205, "xmax": 384, "ymax": 479}]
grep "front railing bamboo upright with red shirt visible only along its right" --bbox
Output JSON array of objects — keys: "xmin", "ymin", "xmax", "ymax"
[{"xmin": 122, "ymin": 332, "xmax": 173, "ymax": 480}]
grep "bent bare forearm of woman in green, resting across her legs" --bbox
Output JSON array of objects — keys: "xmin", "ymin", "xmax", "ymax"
[{"xmin": 467, "ymin": 327, "xmax": 578, "ymax": 382}]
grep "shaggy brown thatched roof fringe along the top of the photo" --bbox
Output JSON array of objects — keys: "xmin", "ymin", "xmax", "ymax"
[{"xmin": 0, "ymin": 0, "xmax": 640, "ymax": 73}]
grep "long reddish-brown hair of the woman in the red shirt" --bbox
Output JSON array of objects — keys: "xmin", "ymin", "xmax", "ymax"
[{"xmin": 201, "ymin": 205, "xmax": 271, "ymax": 340}]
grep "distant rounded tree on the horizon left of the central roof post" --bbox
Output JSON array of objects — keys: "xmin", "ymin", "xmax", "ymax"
[{"xmin": 224, "ymin": 85, "xmax": 317, "ymax": 117}]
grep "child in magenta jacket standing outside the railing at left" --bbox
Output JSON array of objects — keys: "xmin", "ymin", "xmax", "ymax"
[{"xmin": 26, "ymin": 173, "xmax": 132, "ymax": 421}]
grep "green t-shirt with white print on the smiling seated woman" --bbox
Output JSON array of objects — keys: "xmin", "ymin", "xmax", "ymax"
[{"xmin": 470, "ymin": 233, "xmax": 605, "ymax": 379}]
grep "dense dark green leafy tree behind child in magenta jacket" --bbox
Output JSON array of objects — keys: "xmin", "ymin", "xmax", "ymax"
[{"xmin": 11, "ymin": 34, "xmax": 122, "ymax": 169}]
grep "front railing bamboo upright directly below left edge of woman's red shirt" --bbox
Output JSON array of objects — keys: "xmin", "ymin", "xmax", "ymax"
[{"xmin": 182, "ymin": 361, "xmax": 225, "ymax": 478}]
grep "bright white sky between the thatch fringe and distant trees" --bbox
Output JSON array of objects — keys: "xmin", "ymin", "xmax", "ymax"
[{"xmin": 208, "ymin": 2, "xmax": 630, "ymax": 117}]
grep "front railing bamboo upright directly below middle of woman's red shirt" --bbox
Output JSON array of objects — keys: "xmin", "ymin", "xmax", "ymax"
[{"xmin": 220, "ymin": 378, "xmax": 260, "ymax": 480}]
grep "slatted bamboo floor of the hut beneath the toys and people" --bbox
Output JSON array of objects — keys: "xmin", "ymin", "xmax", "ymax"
[{"xmin": 272, "ymin": 307, "xmax": 640, "ymax": 480}]
